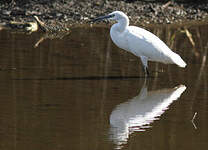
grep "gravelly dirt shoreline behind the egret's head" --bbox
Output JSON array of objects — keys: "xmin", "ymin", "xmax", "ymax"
[{"xmin": 0, "ymin": 0, "xmax": 208, "ymax": 25}]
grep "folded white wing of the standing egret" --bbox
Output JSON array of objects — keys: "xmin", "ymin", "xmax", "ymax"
[{"xmin": 126, "ymin": 26, "xmax": 172, "ymax": 59}]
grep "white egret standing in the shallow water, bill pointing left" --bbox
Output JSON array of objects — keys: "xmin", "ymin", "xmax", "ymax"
[{"xmin": 92, "ymin": 11, "xmax": 186, "ymax": 76}]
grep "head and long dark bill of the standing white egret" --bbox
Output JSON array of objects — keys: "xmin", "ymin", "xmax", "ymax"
[{"xmin": 92, "ymin": 11, "xmax": 129, "ymax": 22}]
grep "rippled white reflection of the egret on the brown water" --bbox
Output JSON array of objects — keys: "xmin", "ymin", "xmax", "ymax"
[{"xmin": 110, "ymin": 83, "xmax": 186, "ymax": 149}]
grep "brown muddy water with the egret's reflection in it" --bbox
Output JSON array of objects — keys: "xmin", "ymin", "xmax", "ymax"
[{"xmin": 0, "ymin": 24, "xmax": 208, "ymax": 150}]
